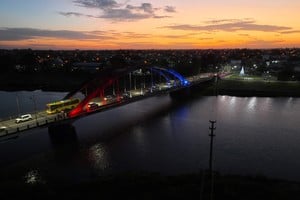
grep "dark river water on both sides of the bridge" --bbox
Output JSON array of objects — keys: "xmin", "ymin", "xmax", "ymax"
[{"xmin": 0, "ymin": 91, "xmax": 300, "ymax": 183}]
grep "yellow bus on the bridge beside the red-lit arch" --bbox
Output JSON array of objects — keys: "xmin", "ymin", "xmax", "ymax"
[{"xmin": 46, "ymin": 98, "xmax": 80, "ymax": 114}]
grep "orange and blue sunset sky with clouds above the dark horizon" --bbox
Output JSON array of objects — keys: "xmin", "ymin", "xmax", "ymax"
[{"xmin": 0, "ymin": 0, "xmax": 300, "ymax": 49}]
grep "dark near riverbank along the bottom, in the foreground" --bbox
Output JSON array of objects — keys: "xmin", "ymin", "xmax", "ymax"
[{"xmin": 0, "ymin": 172, "xmax": 300, "ymax": 200}]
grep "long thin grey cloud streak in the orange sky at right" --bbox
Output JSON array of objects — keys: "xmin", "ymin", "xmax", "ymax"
[{"xmin": 164, "ymin": 19, "xmax": 292, "ymax": 32}]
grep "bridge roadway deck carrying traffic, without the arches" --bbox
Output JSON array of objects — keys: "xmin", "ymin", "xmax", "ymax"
[{"xmin": 0, "ymin": 73, "xmax": 215, "ymax": 140}]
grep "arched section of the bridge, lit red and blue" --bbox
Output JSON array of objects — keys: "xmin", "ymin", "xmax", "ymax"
[{"xmin": 64, "ymin": 67, "xmax": 190, "ymax": 118}]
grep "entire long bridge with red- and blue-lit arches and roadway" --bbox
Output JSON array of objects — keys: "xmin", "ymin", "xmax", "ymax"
[{"xmin": 0, "ymin": 67, "xmax": 216, "ymax": 139}]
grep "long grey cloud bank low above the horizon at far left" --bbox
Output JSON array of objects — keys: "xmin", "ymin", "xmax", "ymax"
[{"xmin": 0, "ymin": 28, "xmax": 111, "ymax": 41}]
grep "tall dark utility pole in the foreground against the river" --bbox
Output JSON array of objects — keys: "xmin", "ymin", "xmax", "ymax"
[{"xmin": 208, "ymin": 120, "xmax": 216, "ymax": 200}]
